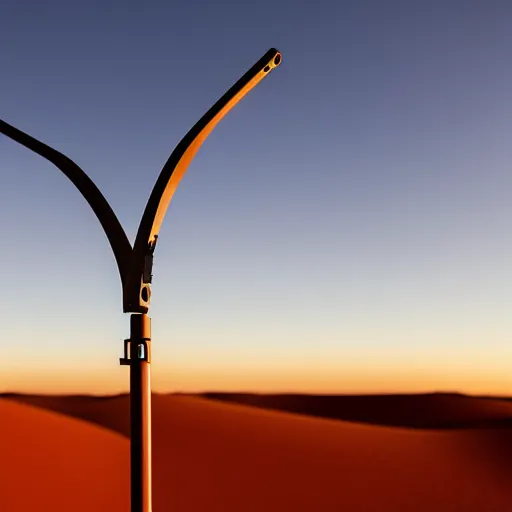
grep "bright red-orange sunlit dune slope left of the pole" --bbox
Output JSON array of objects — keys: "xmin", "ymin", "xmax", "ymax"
[{"xmin": 0, "ymin": 400, "xmax": 129, "ymax": 512}]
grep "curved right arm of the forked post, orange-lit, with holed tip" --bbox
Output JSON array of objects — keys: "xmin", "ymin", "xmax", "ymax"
[{"xmin": 124, "ymin": 48, "xmax": 282, "ymax": 312}]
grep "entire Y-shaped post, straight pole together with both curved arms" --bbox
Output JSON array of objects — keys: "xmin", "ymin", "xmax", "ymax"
[{"xmin": 0, "ymin": 48, "xmax": 282, "ymax": 512}]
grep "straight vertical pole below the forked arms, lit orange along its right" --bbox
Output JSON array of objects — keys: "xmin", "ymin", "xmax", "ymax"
[{"xmin": 129, "ymin": 314, "xmax": 151, "ymax": 512}]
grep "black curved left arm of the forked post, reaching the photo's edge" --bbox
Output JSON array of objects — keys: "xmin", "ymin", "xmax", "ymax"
[{"xmin": 0, "ymin": 120, "xmax": 132, "ymax": 288}]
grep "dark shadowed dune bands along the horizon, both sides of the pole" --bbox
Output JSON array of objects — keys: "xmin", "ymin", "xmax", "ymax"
[{"xmin": 4, "ymin": 392, "xmax": 512, "ymax": 436}]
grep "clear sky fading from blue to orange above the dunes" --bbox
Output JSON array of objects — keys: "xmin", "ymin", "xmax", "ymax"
[{"xmin": 0, "ymin": 0, "xmax": 512, "ymax": 394}]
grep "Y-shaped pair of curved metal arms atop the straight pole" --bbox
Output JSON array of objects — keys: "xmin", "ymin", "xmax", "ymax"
[{"xmin": 0, "ymin": 48, "xmax": 282, "ymax": 313}]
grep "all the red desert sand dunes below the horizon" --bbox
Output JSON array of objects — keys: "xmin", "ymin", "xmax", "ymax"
[{"xmin": 0, "ymin": 394, "xmax": 512, "ymax": 512}]
